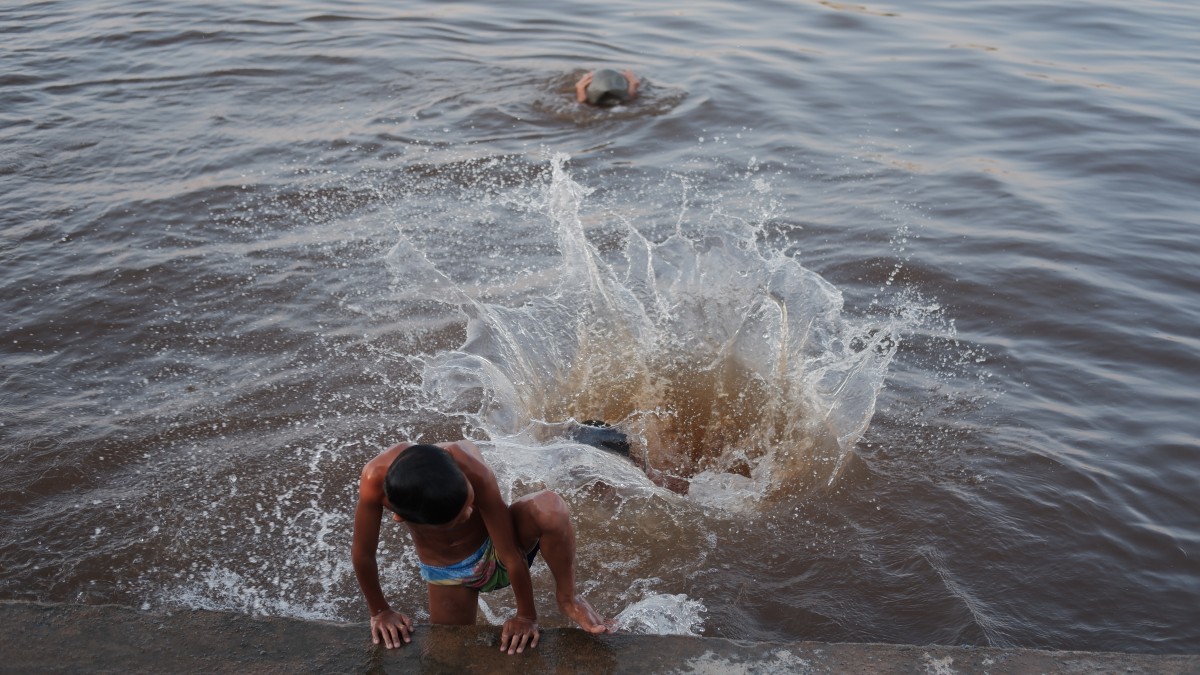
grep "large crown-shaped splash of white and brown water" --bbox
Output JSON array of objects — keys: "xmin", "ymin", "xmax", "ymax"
[{"xmin": 401, "ymin": 155, "xmax": 898, "ymax": 508}]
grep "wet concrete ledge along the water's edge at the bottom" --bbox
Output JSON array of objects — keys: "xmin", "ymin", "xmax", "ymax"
[{"xmin": 0, "ymin": 602, "xmax": 1200, "ymax": 675}]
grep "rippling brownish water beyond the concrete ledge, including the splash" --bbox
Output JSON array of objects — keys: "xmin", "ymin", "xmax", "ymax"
[{"xmin": 0, "ymin": 0, "xmax": 1200, "ymax": 652}]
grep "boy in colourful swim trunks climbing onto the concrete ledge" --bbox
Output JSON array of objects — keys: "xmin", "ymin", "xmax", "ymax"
[{"xmin": 350, "ymin": 441, "xmax": 612, "ymax": 653}]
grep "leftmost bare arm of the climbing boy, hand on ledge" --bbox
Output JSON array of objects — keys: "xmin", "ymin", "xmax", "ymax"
[{"xmin": 350, "ymin": 466, "xmax": 413, "ymax": 649}]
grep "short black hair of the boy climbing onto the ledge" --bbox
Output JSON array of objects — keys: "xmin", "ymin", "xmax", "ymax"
[{"xmin": 384, "ymin": 444, "xmax": 467, "ymax": 525}]
